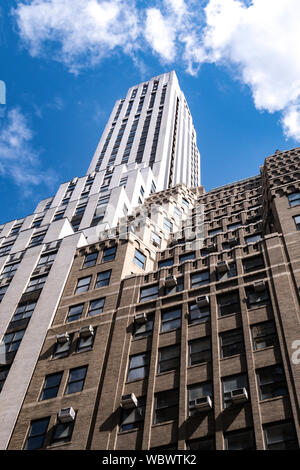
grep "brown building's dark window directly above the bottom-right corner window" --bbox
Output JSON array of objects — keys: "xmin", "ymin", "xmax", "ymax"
[{"xmin": 256, "ymin": 365, "xmax": 288, "ymax": 400}]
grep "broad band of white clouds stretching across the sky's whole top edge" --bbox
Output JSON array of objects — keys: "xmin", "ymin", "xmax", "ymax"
[{"xmin": 14, "ymin": 0, "xmax": 300, "ymax": 140}]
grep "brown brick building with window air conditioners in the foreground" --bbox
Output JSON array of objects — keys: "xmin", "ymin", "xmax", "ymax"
[{"xmin": 8, "ymin": 148, "xmax": 300, "ymax": 450}]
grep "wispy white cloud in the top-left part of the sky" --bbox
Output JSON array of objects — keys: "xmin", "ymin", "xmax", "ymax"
[{"xmin": 13, "ymin": 0, "xmax": 137, "ymax": 72}]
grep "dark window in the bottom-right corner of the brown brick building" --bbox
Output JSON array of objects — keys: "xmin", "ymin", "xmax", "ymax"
[{"xmin": 264, "ymin": 422, "xmax": 299, "ymax": 450}]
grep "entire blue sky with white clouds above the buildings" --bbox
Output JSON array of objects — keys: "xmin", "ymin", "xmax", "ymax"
[{"xmin": 0, "ymin": 0, "xmax": 300, "ymax": 223}]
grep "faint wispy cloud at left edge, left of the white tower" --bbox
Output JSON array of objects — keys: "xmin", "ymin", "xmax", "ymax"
[{"xmin": 0, "ymin": 108, "xmax": 55, "ymax": 190}]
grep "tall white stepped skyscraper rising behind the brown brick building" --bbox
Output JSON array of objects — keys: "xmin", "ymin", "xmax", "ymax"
[{"xmin": 0, "ymin": 72, "xmax": 200, "ymax": 449}]
